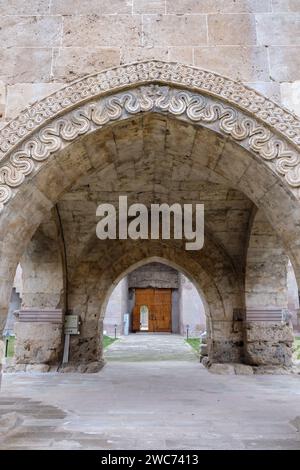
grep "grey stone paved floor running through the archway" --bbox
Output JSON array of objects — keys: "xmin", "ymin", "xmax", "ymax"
[{"xmin": 0, "ymin": 335, "xmax": 300, "ymax": 450}]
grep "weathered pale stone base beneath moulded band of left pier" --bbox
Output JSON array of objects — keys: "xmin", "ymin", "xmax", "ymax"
[{"xmin": 15, "ymin": 322, "xmax": 62, "ymax": 367}]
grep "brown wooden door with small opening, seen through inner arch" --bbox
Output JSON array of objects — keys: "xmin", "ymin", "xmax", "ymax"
[{"xmin": 132, "ymin": 289, "xmax": 172, "ymax": 332}]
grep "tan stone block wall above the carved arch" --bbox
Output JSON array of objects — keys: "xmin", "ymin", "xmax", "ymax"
[{"xmin": 0, "ymin": 0, "xmax": 300, "ymax": 129}]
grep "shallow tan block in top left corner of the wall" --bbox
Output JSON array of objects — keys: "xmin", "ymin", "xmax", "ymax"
[{"xmin": 0, "ymin": 0, "xmax": 49, "ymax": 16}]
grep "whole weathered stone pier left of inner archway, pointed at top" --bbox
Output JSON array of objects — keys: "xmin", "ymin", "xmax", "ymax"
[{"xmin": 10, "ymin": 220, "xmax": 64, "ymax": 371}]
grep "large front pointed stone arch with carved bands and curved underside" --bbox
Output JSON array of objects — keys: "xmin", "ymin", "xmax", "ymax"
[{"xmin": 0, "ymin": 62, "xmax": 300, "ymax": 370}]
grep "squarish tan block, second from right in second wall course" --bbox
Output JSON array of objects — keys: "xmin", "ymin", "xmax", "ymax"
[{"xmin": 207, "ymin": 14, "xmax": 256, "ymax": 46}]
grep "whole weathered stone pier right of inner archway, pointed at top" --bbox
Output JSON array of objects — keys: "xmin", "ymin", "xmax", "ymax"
[{"xmin": 244, "ymin": 210, "xmax": 293, "ymax": 367}]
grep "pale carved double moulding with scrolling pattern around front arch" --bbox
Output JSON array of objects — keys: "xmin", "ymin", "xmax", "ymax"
[{"xmin": 0, "ymin": 61, "xmax": 300, "ymax": 210}]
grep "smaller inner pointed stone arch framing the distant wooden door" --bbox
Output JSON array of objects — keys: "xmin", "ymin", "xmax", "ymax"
[{"xmin": 63, "ymin": 235, "xmax": 243, "ymax": 370}]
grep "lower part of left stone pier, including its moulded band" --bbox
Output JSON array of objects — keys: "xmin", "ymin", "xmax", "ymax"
[{"xmin": 14, "ymin": 309, "xmax": 63, "ymax": 372}]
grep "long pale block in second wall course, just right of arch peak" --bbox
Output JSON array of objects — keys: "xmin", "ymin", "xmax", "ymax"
[{"xmin": 143, "ymin": 15, "xmax": 207, "ymax": 46}]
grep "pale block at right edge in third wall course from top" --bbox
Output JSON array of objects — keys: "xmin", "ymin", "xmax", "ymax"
[{"xmin": 269, "ymin": 46, "xmax": 300, "ymax": 82}]
